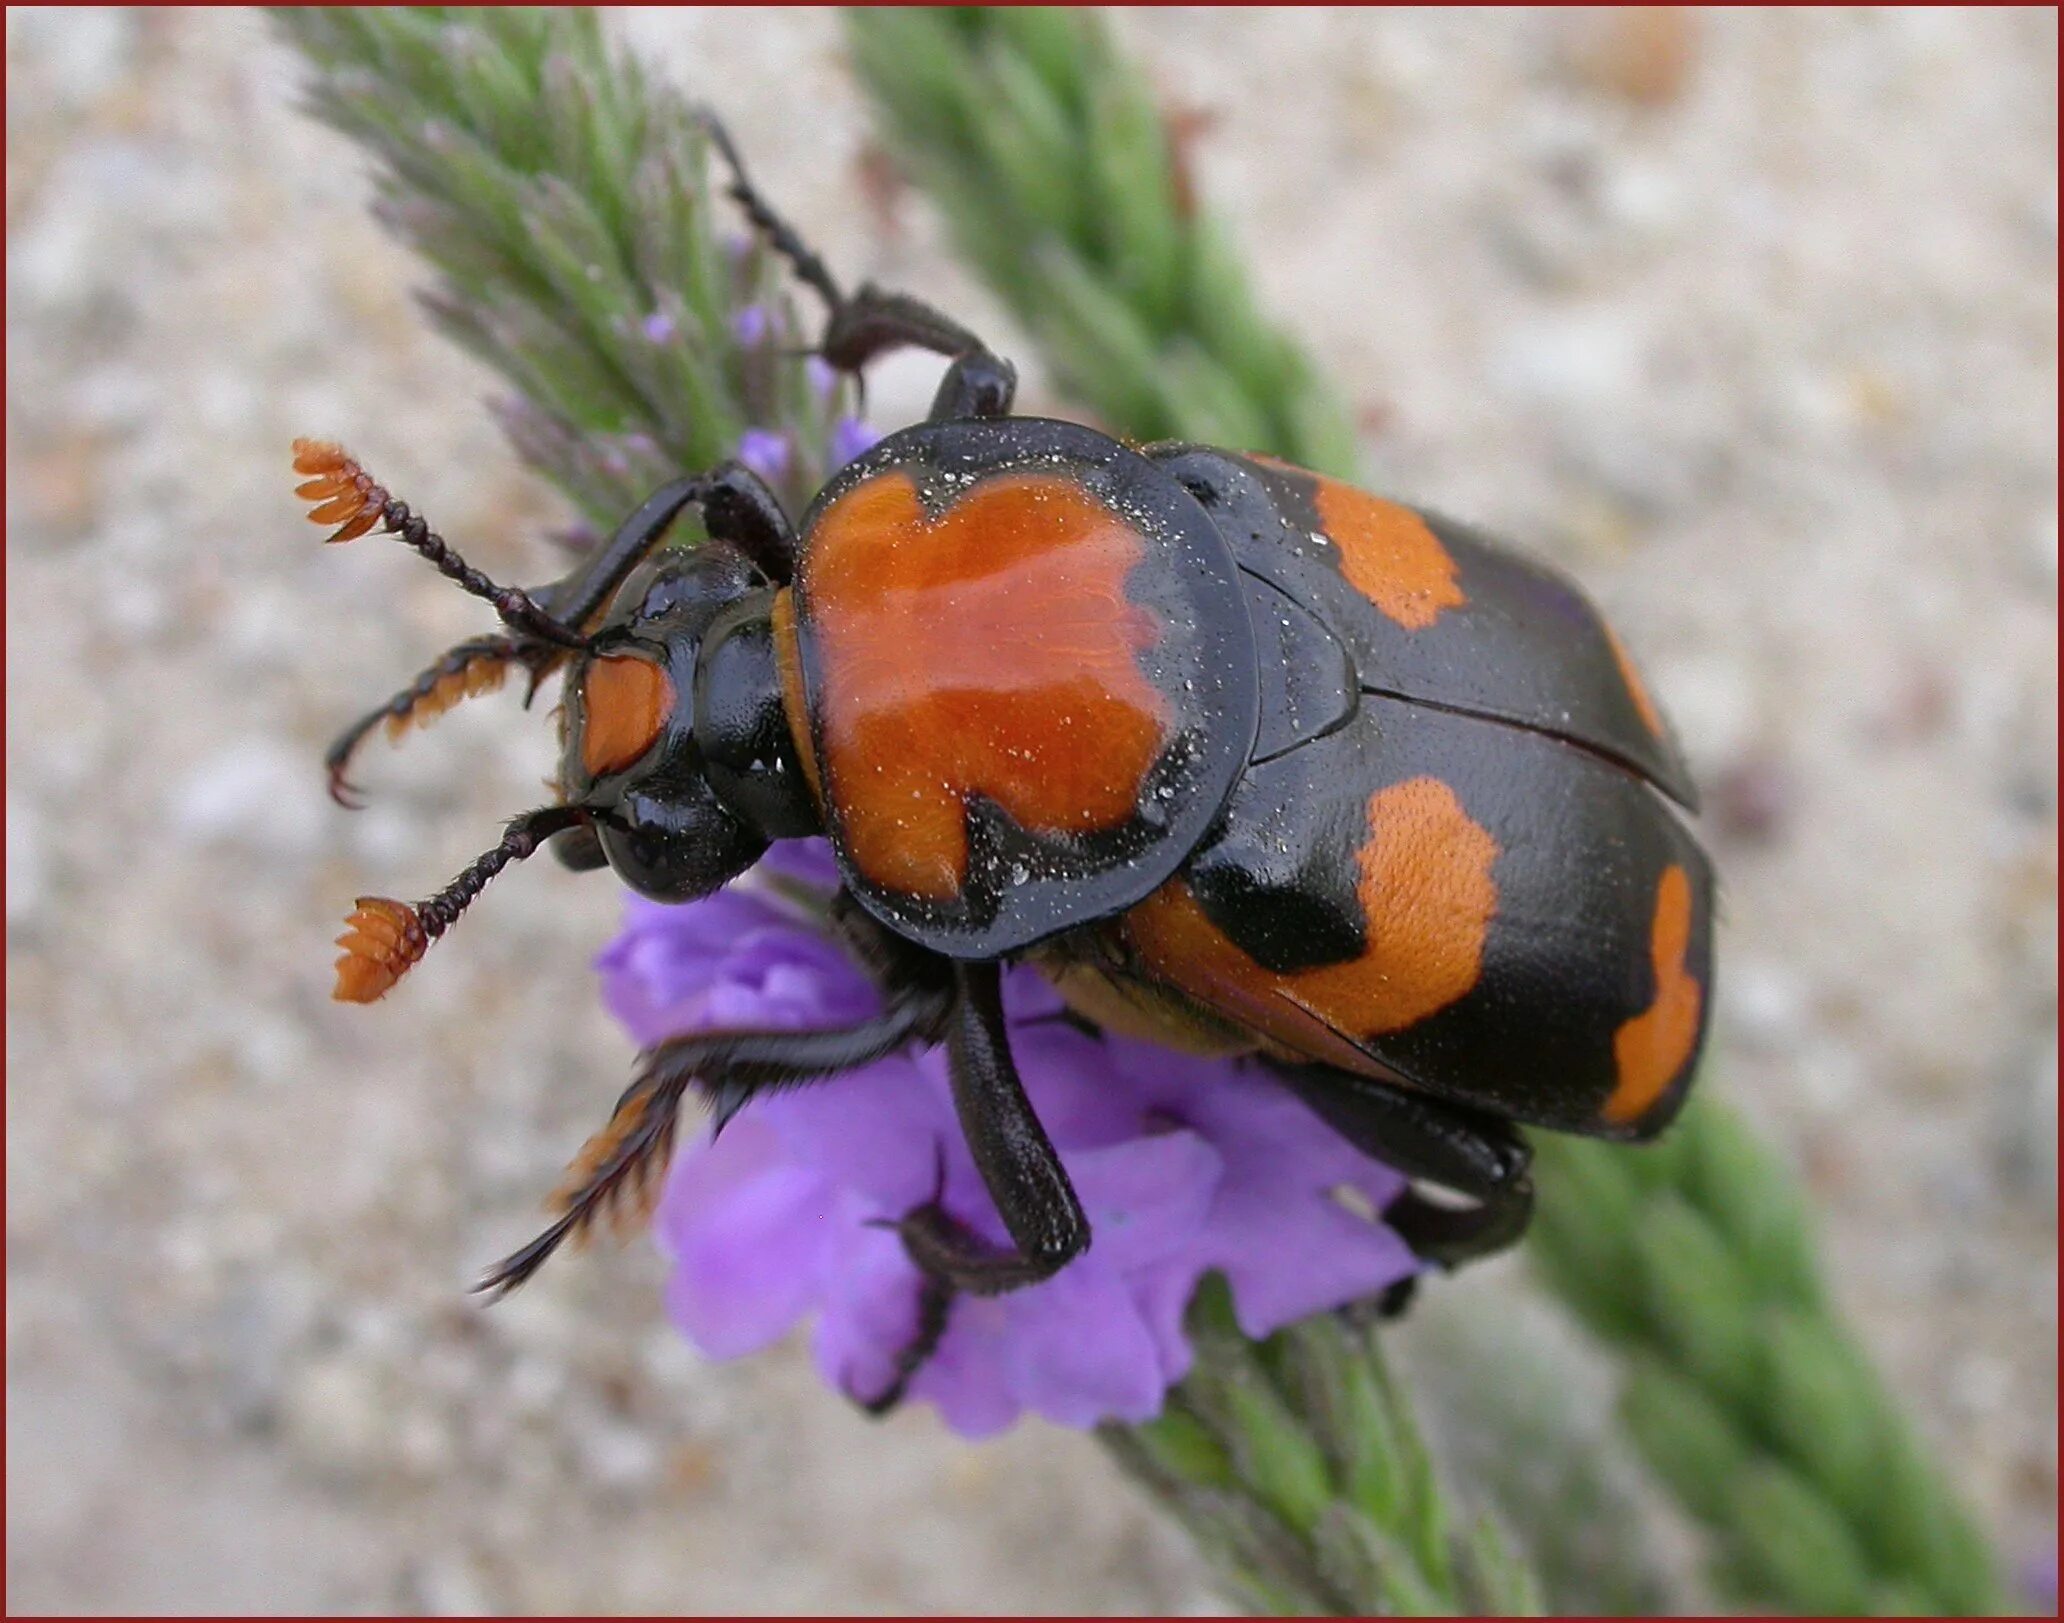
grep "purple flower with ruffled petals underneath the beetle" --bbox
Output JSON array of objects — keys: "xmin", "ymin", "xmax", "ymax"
[{"xmin": 599, "ymin": 840, "xmax": 1418, "ymax": 1437}]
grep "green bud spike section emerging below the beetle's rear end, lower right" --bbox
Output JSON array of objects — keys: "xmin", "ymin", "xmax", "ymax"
[{"xmin": 1529, "ymin": 1099, "xmax": 2006, "ymax": 1613}]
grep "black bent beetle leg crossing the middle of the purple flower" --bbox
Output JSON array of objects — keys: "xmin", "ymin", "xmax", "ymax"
[{"xmin": 898, "ymin": 964, "xmax": 1090, "ymax": 1297}]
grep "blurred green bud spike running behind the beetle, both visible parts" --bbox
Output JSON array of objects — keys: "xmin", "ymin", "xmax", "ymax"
[{"xmin": 846, "ymin": 8, "xmax": 2004, "ymax": 1613}]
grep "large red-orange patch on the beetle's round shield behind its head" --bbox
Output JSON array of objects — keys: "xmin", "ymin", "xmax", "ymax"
[{"xmin": 803, "ymin": 471, "xmax": 1168, "ymax": 900}]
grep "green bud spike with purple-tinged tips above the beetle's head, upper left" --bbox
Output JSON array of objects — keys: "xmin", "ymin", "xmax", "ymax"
[{"xmin": 272, "ymin": 6, "xmax": 846, "ymax": 524}]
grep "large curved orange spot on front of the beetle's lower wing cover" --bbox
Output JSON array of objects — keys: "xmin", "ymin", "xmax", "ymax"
[{"xmin": 1125, "ymin": 776, "xmax": 1498, "ymax": 1065}]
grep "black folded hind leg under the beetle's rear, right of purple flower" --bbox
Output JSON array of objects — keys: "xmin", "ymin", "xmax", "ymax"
[{"xmin": 1273, "ymin": 1065, "xmax": 1534, "ymax": 1268}]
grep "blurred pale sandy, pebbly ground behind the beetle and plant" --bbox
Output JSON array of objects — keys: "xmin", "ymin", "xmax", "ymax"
[{"xmin": 6, "ymin": 10, "xmax": 2058, "ymax": 1613}]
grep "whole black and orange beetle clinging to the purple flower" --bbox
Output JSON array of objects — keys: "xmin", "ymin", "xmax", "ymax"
[{"xmin": 297, "ymin": 130, "xmax": 1713, "ymax": 1293}]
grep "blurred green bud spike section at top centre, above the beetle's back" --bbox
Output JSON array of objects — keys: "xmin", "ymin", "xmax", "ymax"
[{"xmin": 846, "ymin": 6, "xmax": 1356, "ymax": 473}]
